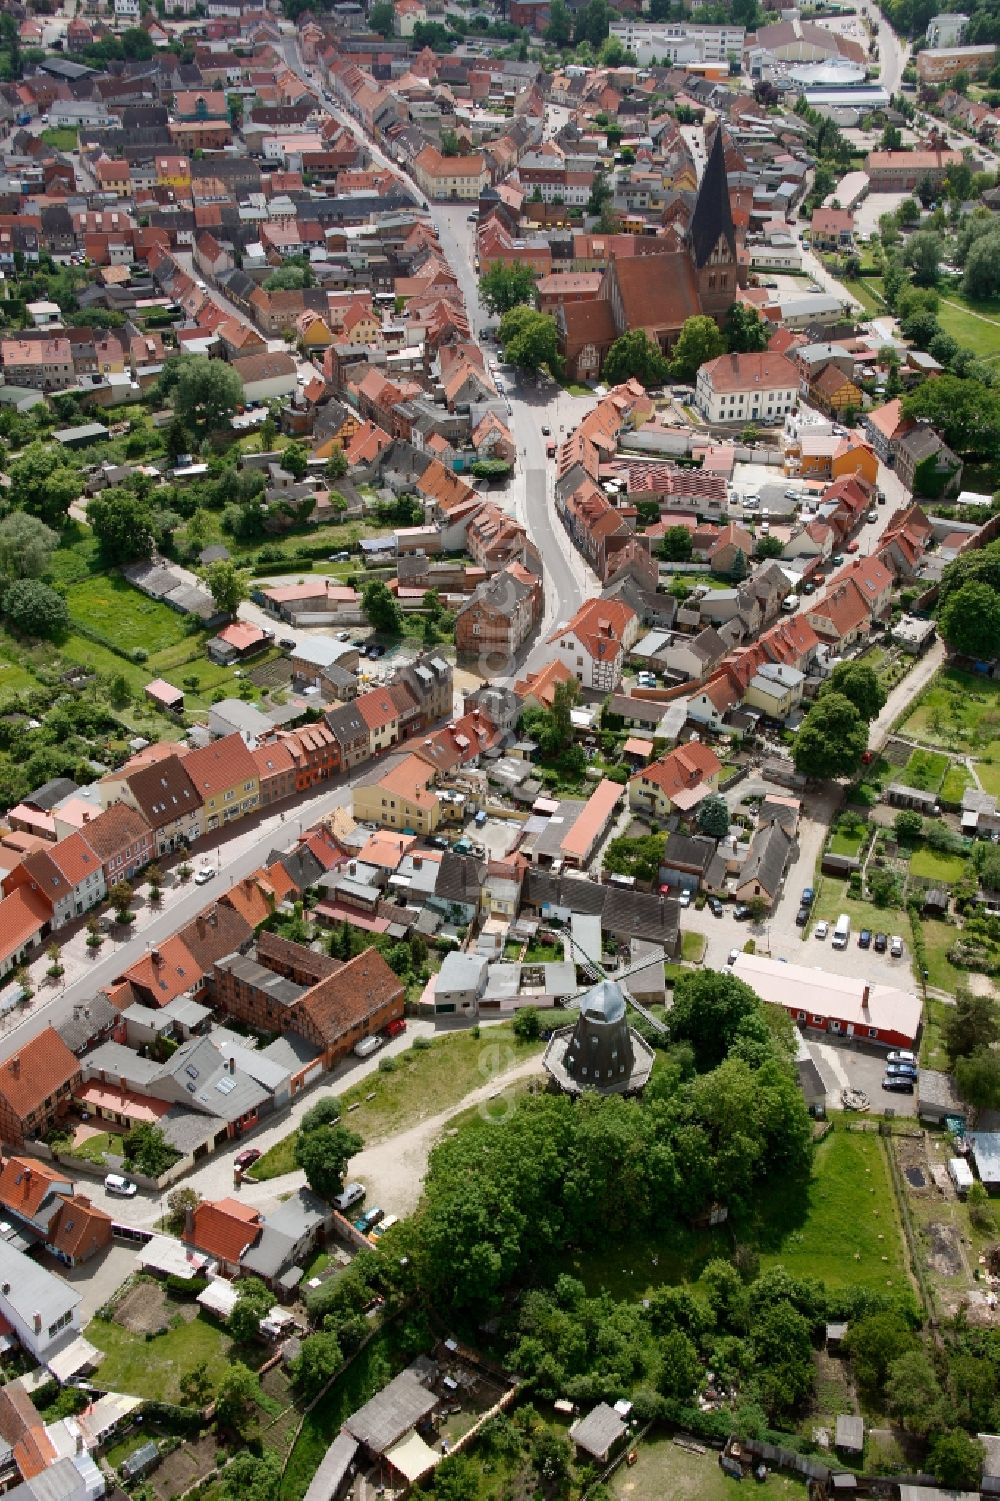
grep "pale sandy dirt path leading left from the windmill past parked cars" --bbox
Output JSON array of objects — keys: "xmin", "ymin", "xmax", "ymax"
[{"xmin": 240, "ymin": 1054, "xmax": 542, "ymax": 1217}]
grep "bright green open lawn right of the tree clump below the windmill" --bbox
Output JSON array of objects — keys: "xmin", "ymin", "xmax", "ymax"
[{"xmin": 757, "ymin": 1121, "xmax": 908, "ymax": 1291}]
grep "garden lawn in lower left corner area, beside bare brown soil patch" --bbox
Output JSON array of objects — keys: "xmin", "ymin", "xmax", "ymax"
[{"xmin": 86, "ymin": 1304, "xmax": 233, "ymax": 1402}]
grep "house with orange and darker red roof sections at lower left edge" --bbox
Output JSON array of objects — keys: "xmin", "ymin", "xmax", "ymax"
[{"xmin": 0, "ymin": 1157, "xmax": 111, "ymax": 1267}]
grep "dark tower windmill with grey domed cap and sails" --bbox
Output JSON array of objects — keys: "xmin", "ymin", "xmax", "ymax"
[{"xmin": 542, "ymin": 934, "xmax": 667, "ymax": 1094}]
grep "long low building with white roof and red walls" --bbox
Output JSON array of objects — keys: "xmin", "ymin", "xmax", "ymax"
[{"xmin": 723, "ymin": 953, "xmax": 920, "ymax": 1049}]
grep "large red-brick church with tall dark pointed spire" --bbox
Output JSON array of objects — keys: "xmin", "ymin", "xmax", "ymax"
[{"xmin": 556, "ymin": 129, "xmax": 746, "ymax": 381}]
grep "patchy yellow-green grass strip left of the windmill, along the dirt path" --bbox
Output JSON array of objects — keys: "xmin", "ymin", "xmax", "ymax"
[{"xmin": 252, "ymin": 1012, "xmax": 540, "ymax": 1180}]
